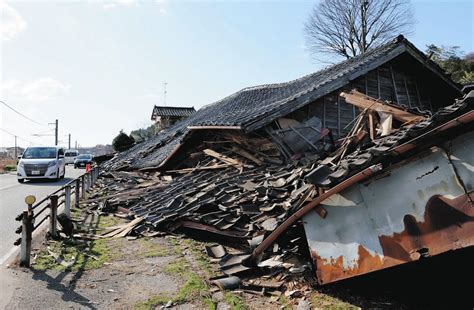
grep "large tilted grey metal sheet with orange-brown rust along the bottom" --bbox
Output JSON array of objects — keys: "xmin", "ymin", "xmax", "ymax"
[{"xmin": 303, "ymin": 133, "xmax": 474, "ymax": 284}]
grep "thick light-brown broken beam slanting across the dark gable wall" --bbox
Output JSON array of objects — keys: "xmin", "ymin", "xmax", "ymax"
[{"xmin": 341, "ymin": 90, "xmax": 426, "ymax": 123}]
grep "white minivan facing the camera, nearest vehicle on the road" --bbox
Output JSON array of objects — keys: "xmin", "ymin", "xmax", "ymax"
[{"xmin": 17, "ymin": 146, "xmax": 66, "ymax": 183}]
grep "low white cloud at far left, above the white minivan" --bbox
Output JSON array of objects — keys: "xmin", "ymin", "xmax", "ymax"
[{"xmin": 1, "ymin": 77, "xmax": 70, "ymax": 102}]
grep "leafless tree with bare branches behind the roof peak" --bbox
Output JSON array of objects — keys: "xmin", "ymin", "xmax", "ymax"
[{"xmin": 304, "ymin": 0, "xmax": 414, "ymax": 58}]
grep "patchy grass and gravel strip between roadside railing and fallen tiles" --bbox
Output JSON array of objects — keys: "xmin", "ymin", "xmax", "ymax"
[{"xmin": 28, "ymin": 209, "xmax": 354, "ymax": 310}]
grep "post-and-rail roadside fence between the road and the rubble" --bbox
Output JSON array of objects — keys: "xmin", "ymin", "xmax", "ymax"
[{"xmin": 13, "ymin": 166, "xmax": 99, "ymax": 267}]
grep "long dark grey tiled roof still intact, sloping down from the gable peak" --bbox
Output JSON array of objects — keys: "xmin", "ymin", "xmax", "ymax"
[{"xmin": 109, "ymin": 35, "xmax": 460, "ymax": 169}]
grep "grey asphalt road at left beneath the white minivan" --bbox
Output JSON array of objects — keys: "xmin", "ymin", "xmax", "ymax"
[{"xmin": 0, "ymin": 166, "xmax": 84, "ymax": 265}]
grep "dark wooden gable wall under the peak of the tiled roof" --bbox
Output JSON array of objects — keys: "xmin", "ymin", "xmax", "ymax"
[{"xmin": 286, "ymin": 55, "xmax": 457, "ymax": 137}]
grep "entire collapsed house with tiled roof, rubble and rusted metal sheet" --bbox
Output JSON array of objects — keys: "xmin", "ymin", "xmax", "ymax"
[{"xmin": 95, "ymin": 36, "xmax": 474, "ymax": 286}]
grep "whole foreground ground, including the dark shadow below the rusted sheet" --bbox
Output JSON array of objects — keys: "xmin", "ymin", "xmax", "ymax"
[{"xmin": 6, "ymin": 210, "xmax": 474, "ymax": 310}]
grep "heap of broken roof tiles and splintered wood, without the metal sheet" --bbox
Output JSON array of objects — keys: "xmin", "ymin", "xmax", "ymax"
[{"xmin": 89, "ymin": 91, "xmax": 473, "ymax": 294}]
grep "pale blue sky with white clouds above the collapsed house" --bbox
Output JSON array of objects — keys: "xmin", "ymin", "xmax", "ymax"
[{"xmin": 0, "ymin": 0, "xmax": 474, "ymax": 146}]
